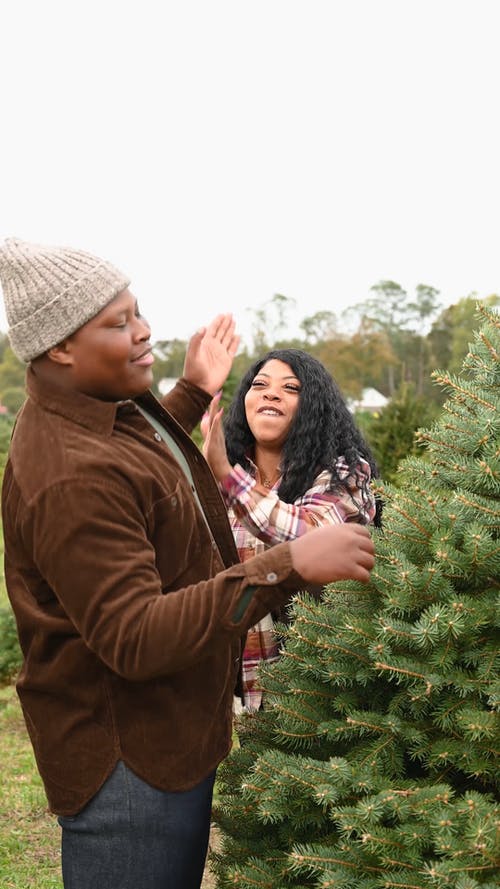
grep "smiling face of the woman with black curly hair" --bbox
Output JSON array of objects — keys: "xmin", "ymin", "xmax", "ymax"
[{"xmin": 245, "ymin": 358, "xmax": 301, "ymax": 448}]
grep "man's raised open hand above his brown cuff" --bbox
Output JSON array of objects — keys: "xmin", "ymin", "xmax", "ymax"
[{"xmin": 183, "ymin": 315, "xmax": 240, "ymax": 395}]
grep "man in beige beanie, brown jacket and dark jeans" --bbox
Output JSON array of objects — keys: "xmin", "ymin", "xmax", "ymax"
[{"xmin": 0, "ymin": 239, "xmax": 374, "ymax": 889}]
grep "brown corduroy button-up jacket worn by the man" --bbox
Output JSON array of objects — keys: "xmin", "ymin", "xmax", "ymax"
[{"xmin": 2, "ymin": 368, "xmax": 303, "ymax": 815}]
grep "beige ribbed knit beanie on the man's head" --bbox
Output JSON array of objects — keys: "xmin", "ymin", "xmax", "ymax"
[{"xmin": 0, "ymin": 238, "xmax": 130, "ymax": 361}]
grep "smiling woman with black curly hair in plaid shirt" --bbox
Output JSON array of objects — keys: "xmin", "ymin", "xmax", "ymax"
[{"xmin": 202, "ymin": 349, "xmax": 380, "ymax": 710}]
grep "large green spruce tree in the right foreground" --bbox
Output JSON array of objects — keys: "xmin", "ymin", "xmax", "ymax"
[{"xmin": 212, "ymin": 307, "xmax": 500, "ymax": 889}]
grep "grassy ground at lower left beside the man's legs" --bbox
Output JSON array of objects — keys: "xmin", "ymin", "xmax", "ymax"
[{"xmin": 0, "ymin": 583, "xmax": 219, "ymax": 889}]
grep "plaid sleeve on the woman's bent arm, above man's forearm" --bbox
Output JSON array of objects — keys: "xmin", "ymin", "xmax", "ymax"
[{"xmin": 221, "ymin": 458, "xmax": 375, "ymax": 546}]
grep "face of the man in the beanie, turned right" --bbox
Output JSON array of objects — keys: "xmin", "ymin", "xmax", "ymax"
[{"xmin": 64, "ymin": 290, "xmax": 154, "ymax": 401}]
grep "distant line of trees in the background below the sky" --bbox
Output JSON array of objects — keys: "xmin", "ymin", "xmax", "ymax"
[{"xmin": 0, "ymin": 280, "xmax": 500, "ymax": 480}]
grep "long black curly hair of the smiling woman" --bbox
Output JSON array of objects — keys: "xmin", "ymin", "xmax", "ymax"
[{"xmin": 224, "ymin": 349, "xmax": 381, "ymax": 525}]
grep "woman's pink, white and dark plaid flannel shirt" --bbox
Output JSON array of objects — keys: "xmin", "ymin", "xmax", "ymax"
[{"xmin": 220, "ymin": 457, "xmax": 375, "ymax": 710}]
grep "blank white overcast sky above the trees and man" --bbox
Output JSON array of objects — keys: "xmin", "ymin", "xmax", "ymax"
[{"xmin": 0, "ymin": 0, "xmax": 500, "ymax": 341}]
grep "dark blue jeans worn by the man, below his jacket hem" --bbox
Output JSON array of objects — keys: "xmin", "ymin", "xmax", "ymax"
[{"xmin": 58, "ymin": 762, "xmax": 215, "ymax": 889}]
